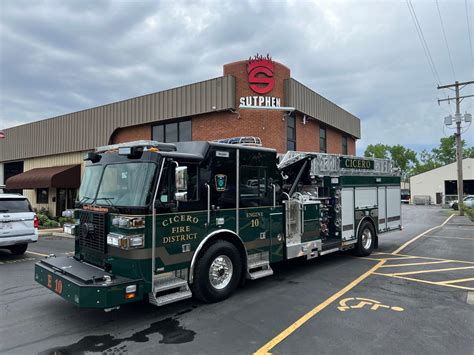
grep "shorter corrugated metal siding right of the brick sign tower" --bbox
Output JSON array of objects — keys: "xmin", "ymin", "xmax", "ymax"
[{"xmin": 285, "ymin": 79, "xmax": 360, "ymax": 138}]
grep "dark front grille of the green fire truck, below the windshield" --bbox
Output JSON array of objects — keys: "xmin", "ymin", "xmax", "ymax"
[{"xmin": 79, "ymin": 211, "xmax": 107, "ymax": 254}]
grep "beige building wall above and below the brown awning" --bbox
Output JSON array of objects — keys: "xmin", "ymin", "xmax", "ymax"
[{"xmin": 23, "ymin": 152, "xmax": 85, "ymax": 216}]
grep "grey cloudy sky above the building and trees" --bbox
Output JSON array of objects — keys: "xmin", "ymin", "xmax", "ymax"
[{"xmin": 0, "ymin": 0, "xmax": 474, "ymax": 153}]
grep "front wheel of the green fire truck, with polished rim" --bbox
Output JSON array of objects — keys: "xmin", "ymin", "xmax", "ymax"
[{"xmin": 191, "ymin": 240, "xmax": 242, "ymax": 303}]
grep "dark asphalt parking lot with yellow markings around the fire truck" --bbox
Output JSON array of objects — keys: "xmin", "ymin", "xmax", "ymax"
[{"xmin": 0, "ymin": 206, "xmax": 474, "ymax": 354}]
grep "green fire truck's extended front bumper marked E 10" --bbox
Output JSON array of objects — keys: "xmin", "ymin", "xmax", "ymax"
[{"xmin": 35, "ymin": 256, "xmax": 144, "ymax": 308}]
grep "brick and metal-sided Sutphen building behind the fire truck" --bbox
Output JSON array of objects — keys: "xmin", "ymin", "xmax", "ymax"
[{"xmin": 0, "ymin": 56, "xmax": 360, "ymax": 215}]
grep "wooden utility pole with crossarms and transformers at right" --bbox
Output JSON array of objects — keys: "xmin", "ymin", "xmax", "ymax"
[{"xmin": 438, "ymin": 81, "xmax": 474, "ymax": 216}]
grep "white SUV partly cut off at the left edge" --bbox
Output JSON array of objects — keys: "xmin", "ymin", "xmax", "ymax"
[{"xmin": 0, "ymin": 193, "xmax": 39, "ymax": 255}]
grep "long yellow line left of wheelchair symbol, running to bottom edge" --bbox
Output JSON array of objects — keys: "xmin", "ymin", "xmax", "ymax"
[{"xmin": 255, "ymin": 260, "xmax": 385, "ymax": 355}]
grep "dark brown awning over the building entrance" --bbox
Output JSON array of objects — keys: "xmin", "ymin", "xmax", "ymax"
[{"xmin": 6, "ymin": 165, "xmax": 81, "ymax": 189}]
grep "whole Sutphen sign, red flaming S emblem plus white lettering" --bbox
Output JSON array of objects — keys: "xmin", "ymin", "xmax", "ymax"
[{"xmin": 239, "ymin": 54, "xmax": 281, "ymax": 108}]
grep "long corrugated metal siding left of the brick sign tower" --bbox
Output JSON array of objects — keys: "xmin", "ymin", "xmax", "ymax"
[{"xmin": 0, "ymin": 76, "xmax": 235, "ymax": 161}]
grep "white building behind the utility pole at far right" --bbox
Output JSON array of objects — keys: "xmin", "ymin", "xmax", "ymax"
[{"xmin": 410, "ymin": 158, "xmax": 474, "ymax": 204}]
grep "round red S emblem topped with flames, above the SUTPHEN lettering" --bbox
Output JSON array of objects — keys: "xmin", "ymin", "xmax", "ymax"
[{"xmin": 247, "ymin": 54, "xmax": 275, "ymax": 94}]
